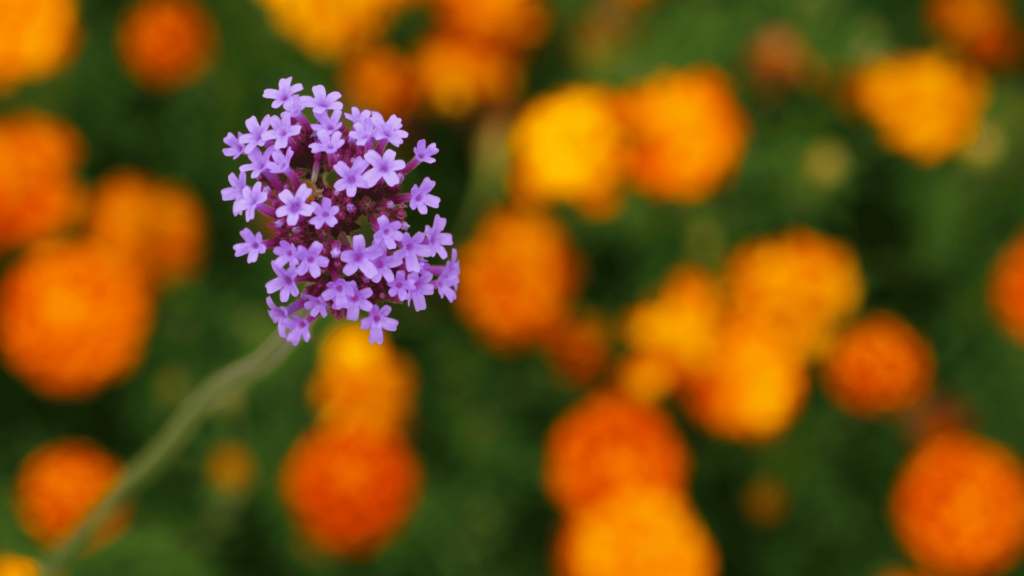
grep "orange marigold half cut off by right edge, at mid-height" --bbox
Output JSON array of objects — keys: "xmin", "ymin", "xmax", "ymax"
[{"xmin": 987, "ymin": 233, "xmax": 1024, "ymax": 345}]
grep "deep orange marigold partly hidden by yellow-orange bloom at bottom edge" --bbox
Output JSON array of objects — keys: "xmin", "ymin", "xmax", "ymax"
[{"xmin": 542, "ymin": 393, "xmax": 693, "ymax": 510}]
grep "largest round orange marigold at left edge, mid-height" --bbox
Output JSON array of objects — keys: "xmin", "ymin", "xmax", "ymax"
[{"xmin": 0, "ymin": 242, "xmax": 156, "ymax": 402}]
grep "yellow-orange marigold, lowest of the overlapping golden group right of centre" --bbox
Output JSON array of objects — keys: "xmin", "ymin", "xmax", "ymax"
[{"xmin": 680, "ymin": 322, "xmax": 810, "ymax": 444}]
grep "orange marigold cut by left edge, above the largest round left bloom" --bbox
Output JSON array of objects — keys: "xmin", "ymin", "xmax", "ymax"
[{"xmin": 0, "ymin": 112, "xmax": 85, "ymax": 252}]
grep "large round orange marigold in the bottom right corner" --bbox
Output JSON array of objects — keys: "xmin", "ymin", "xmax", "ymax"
[{"xmin": 889, "ymin": 431, "xmax": 1024, "ymax": 576}]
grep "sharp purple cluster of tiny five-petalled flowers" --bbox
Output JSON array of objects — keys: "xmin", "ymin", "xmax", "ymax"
[{"xmin": 228, "ymin": 78, "xmax": 460, "ymax": 345}]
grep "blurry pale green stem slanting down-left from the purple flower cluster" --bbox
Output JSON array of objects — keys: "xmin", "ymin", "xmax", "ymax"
[{"xmin": 43, "ymin": 331, "xmax": 294, "ymax": 576}]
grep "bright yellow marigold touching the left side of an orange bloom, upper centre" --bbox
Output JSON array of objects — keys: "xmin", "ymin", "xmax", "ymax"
[{"xmin": 509, "ymin": 84, "xmax": 624, "ymax": 217}]
